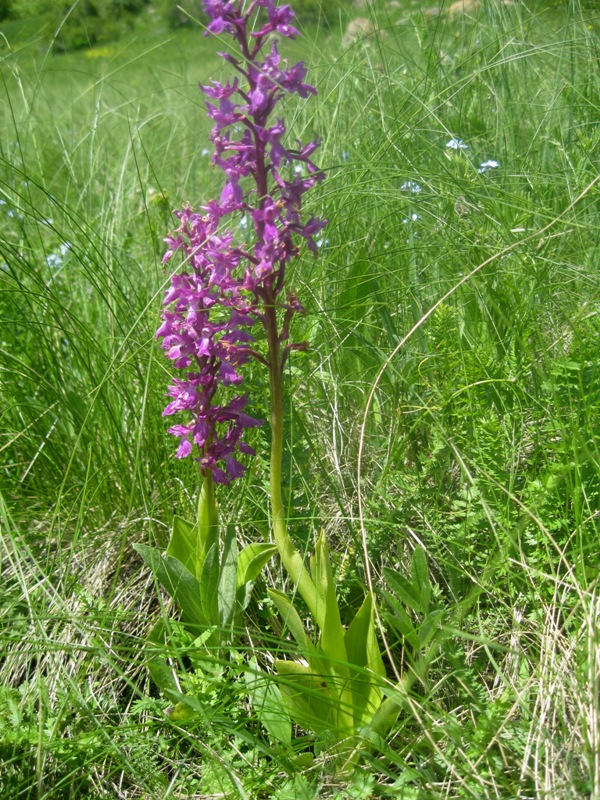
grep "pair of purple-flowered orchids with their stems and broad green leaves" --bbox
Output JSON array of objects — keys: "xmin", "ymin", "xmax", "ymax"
[{"xmin": 138, "ymin": 0, "xmax": 398, "ymax": 752}]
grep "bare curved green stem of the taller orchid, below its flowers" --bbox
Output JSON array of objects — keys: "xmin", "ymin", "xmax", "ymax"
[{"xmin": 265, "ymin": 302, "xmax": 324, "ymax": 629}]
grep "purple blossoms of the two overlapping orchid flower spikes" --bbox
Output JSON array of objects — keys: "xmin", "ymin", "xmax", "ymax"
[{"xmin": 156, "ymin": 0, "xmax": 326, "ymax": 484}]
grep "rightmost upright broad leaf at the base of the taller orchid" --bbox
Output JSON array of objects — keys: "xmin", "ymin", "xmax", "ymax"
[{"xmin": 345, "ymin": 593, "xmax": 385, "ymax": 729}]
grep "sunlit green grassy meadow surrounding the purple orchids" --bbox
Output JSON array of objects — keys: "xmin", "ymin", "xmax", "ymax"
[{"xmin": 0, "ymin": 0, "xmax": 600, "ymax": 800}]
